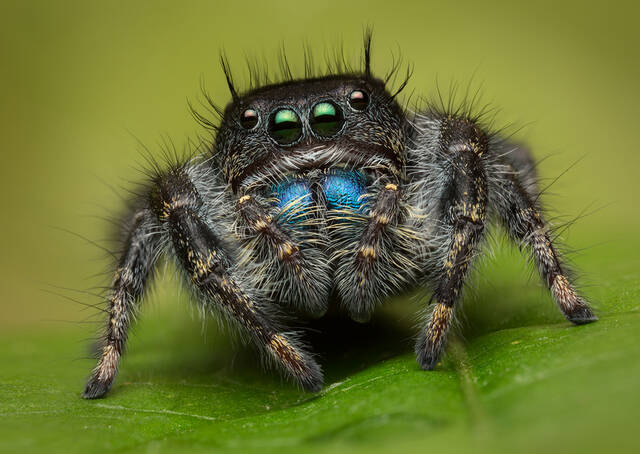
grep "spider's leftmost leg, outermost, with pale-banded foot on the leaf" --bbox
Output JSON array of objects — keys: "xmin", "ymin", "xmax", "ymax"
[{"xmin": 82, "ymin": 210, "xmax": 158, "ymax": 399}]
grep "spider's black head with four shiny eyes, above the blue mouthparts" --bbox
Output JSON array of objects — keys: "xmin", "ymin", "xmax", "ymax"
[{"xmin": 216, "ymin": 76, "xmax": 406, "ymax": 190}]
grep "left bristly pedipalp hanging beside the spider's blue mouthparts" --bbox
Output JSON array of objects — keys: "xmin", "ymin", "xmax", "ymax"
[{"xmin": 236, "ymin": 195, "xmax": 331, "ymax": 317}]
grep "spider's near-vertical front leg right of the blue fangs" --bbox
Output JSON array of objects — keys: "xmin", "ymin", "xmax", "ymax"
[{"xmin": 416, "ymin": 117, "xmax": 488, "ymax": 370}]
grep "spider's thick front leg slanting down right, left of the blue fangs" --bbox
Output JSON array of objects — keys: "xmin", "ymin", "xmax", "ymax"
[{"xmin": 157, "ymin": 168, "xmax": 322, "ymax": 391}]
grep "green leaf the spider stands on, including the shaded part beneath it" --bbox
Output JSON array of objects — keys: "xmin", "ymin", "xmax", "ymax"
[{"xmin": 0, "ymin": 239, "xmax": 640, "ymax": 452}]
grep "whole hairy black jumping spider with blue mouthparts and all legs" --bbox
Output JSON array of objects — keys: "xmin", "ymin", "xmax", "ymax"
[{"xmin": 83, "ymin": 36, "xmax": 596, "ymax": 398}]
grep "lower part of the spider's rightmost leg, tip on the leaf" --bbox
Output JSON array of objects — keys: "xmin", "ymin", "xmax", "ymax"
[{"xmin": 494, "ymin": 162, "xmax": 597, "ymax": 325}]
